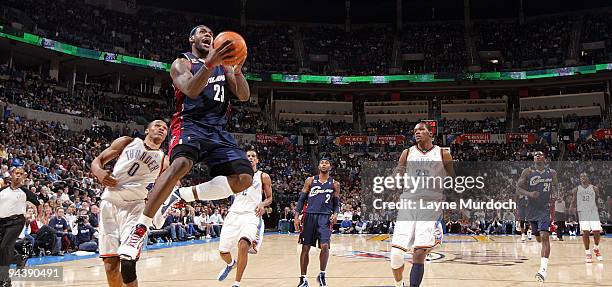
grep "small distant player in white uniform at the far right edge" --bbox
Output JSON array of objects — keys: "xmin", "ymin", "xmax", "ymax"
[{"xmin": 571, "ymin": 173, "xmax": 603, "ymax": 263}]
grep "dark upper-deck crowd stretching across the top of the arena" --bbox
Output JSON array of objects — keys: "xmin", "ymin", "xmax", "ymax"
[{"xmin": 2, "ymin": 0, "xmax": 611, "ymax": 75}]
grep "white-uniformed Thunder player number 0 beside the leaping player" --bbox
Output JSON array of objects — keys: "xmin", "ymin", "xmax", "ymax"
[{"xmin": 91, "ymin": 120, "xmax": 169, "ymax": 287}]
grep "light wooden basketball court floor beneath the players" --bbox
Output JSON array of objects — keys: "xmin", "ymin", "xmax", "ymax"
[{"xmin": 23, "ymin": 234, "xmax": 612, "ymax": 287}]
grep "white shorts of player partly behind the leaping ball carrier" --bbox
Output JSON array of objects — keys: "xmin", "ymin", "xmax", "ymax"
[{"xmin": 219, "ymin": 212, "xmax": 264, "ymax": 253}]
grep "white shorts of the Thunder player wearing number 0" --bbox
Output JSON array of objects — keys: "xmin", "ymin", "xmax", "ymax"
[{"xmin": 99, "ymin": 200, "xmax": 145, "ymax": 258}]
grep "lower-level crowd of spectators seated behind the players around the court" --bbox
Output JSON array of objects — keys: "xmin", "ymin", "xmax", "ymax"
[{"xmin": 0, "ymin": 109, "xmax": 612, "ymax": 260}]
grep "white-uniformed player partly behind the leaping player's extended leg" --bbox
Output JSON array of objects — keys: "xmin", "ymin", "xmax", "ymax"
[{"xmin": 217, "ymin": 150, "xmax": 272, "ymax": 287}]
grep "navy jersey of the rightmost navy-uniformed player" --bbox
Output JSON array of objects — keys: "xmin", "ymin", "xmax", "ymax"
[{"xmin": 527, "ymin": 168, "xmax": 554, "ymax": 220}]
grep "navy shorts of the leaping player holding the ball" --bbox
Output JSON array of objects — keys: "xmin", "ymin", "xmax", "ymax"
[{"xmin": 169, "ymin": 120, "xmax": 253, "ymax": 177}]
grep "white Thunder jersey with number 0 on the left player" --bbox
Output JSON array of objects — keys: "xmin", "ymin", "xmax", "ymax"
[{"xmin": 101, "ymin": 138, "xmax": 164, "ymax": 204}]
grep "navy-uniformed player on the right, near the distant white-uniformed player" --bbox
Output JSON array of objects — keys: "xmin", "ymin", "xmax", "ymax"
[{"xmin": 516, "ymin": 151, "xmax": 559, "ymax": 282}]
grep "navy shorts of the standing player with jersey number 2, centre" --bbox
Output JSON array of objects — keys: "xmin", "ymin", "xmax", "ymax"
[{"xmin": 298, "ymin": 213, "xmax": 332, "ymax": 247}]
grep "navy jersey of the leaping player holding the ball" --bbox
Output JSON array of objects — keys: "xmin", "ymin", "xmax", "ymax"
[{"xmin": 171, "ymin": 52, "xmax": 232, "ymax": 129}]
